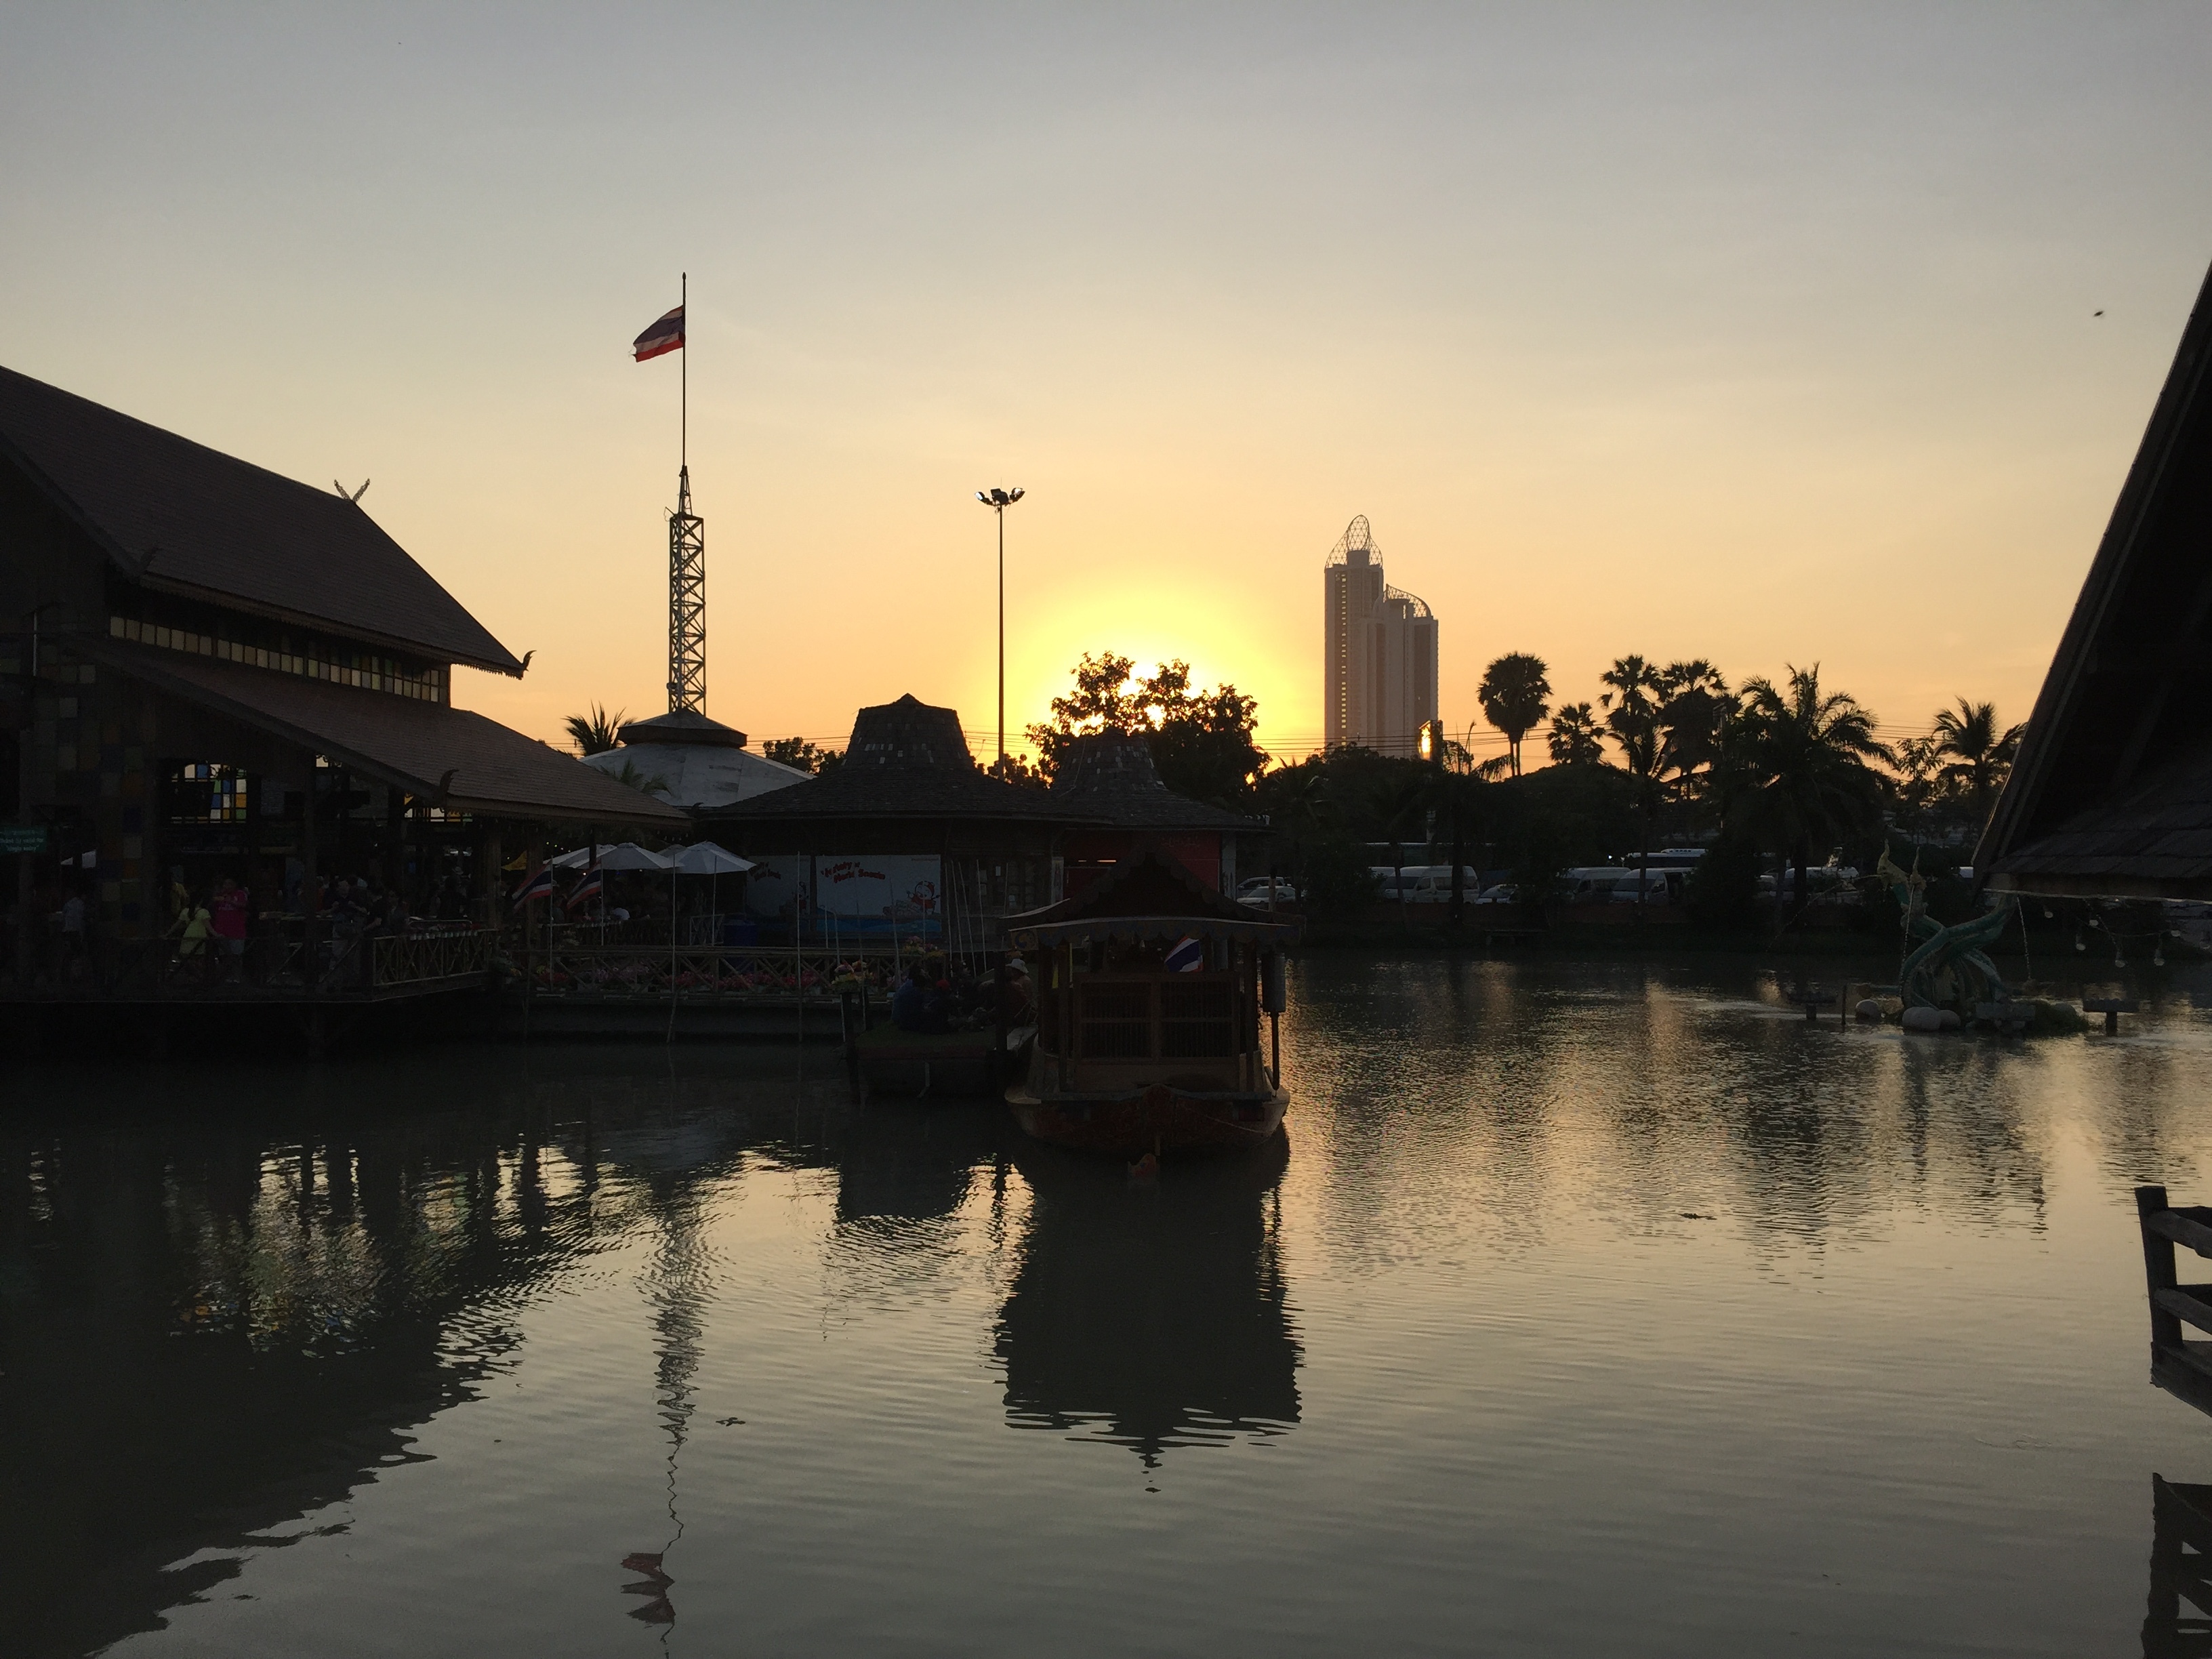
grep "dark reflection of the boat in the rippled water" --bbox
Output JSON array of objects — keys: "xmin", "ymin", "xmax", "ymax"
[{"xmin": 998, "ymin": 1137, "xmax": 1298, "ymax": 1465}]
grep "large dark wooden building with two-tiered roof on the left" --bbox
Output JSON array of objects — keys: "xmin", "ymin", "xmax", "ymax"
[{"xmin": 0, "ymin": 369, "xmax": 688, "ymax": 982}]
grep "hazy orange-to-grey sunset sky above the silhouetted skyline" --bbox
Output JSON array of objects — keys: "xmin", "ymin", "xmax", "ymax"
[{"xmin": 0, "ymin": 5, "xmax": 2212, "ymax": 756}]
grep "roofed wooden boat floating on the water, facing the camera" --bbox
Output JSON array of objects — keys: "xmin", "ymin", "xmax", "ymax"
[{"xmin": 1006, "ymin": 849, "xmax": 1298, "ymax": 1159}]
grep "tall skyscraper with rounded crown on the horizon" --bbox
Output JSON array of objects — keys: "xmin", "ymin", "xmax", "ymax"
[{"xmin": 1321, "ymin": 518, "xmax": 1435, "ymax": 754}]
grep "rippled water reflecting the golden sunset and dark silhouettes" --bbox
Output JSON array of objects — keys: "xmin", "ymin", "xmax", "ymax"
[{"xmin": 13, "ymin": 958, "xmax": 2212, "ymax": 1659}]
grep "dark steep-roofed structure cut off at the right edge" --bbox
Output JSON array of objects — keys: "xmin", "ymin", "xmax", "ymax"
[{"xmin": 1973, "ymin": 260, "xmax": 2212, "ymax": 900}]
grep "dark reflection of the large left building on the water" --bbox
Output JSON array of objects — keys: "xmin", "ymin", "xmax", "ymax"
[{"xmin": 0, "ymin": 1101, "xmax": 590, "ymax": 1654}]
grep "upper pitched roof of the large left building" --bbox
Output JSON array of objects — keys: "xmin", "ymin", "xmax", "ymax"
[{"xmin": 0, "ymin": 369, "xmax": 522, "ymax": 675}]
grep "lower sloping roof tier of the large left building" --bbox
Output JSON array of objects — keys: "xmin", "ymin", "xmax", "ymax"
[{"xmin": 88, "ymin": 639, "xmax": 690, "ymax": 830}]
